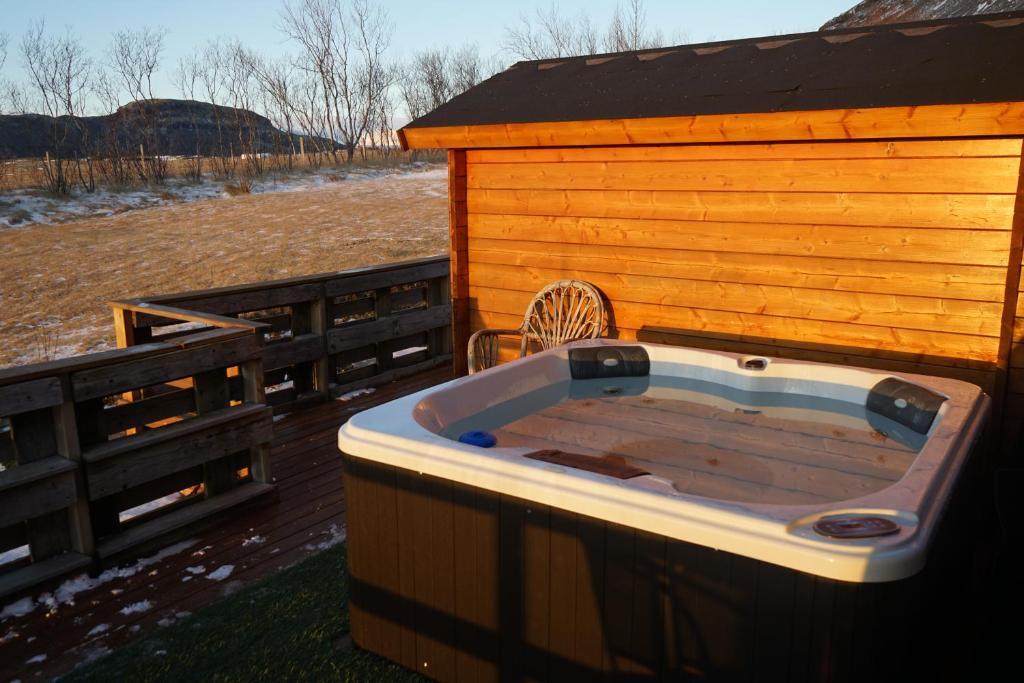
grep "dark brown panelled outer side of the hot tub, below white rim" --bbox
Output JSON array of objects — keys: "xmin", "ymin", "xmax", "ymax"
[{"xmin": 345, "ymin": 456, "xmax": 971, "ymax": 683}]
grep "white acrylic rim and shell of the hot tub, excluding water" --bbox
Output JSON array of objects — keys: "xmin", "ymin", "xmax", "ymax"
[{"xmin": 338, "ymin": 340, "xmax": 988, "ymax": 582}]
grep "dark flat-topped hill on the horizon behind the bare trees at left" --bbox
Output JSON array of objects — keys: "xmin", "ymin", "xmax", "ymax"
[{"xmin": 0, "ymin": 99, "xmax": 329, "ymax": 159}]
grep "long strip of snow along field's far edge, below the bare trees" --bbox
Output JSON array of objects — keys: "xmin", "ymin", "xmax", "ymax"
[{"xmin": 0, "ymin": 162, "xmax": 447, "ymax": 230}]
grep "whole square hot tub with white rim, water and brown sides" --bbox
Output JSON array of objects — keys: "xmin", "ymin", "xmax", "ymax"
[{"xmin": 339, "ymin": 340, "xmax": 989, "ymax": 680}]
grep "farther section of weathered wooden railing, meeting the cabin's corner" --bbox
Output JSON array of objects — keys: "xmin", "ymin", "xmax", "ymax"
[{"xmin": 112, "ymin": 256, "xmax": 452, "ymax": 413}]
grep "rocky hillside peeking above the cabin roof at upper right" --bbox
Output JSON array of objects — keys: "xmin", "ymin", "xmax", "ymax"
[{"xmin": 821, "ymin": 0, "xmax": 1024, "ymax": 31}]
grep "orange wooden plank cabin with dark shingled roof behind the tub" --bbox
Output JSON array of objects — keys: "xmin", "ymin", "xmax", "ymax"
[{"xmin": 400, "ymin": 12, "xmax": 1024, "ymax": 448}]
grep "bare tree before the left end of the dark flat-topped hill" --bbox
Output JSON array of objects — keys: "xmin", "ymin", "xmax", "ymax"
[{"xmin": 109, "ymin": 27, "xmax": 167, "ymax": 182}]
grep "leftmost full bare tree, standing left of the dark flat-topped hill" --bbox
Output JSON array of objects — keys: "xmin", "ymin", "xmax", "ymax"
[{"xmin": 20, "ymin": 20, "xmax": 95, "ymax": 195}]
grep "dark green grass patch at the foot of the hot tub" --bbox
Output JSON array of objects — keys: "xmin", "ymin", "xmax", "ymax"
[{"xmin": 61, "ymin": 546, "xmax": 423, "ymax": 683}]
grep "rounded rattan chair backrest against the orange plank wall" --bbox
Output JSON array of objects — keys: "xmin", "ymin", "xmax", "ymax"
[{"xmin": 522, "ymin": 280, "xmax": 604, "ymax": 354}]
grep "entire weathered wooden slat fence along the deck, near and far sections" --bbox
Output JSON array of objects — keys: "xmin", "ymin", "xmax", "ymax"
[{"xmin": 0, "ymin": 257, "xmax": 452, "ymax": 596}]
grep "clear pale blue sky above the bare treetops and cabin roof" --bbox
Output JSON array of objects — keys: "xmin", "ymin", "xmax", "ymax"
[{"xmin": 0, "ymin": 0, "xmax": 856, "ymax": 107}]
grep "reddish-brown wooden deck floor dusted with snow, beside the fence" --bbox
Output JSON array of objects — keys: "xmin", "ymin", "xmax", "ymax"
[{"xmin": 0, "ymin": 367, "xmax": 451, "ymax": 680}]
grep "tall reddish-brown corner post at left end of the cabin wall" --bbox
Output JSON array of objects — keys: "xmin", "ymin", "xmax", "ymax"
[{"xmin": 449, "ymin": 150, "xmax": 469, "ymax": 376}]
